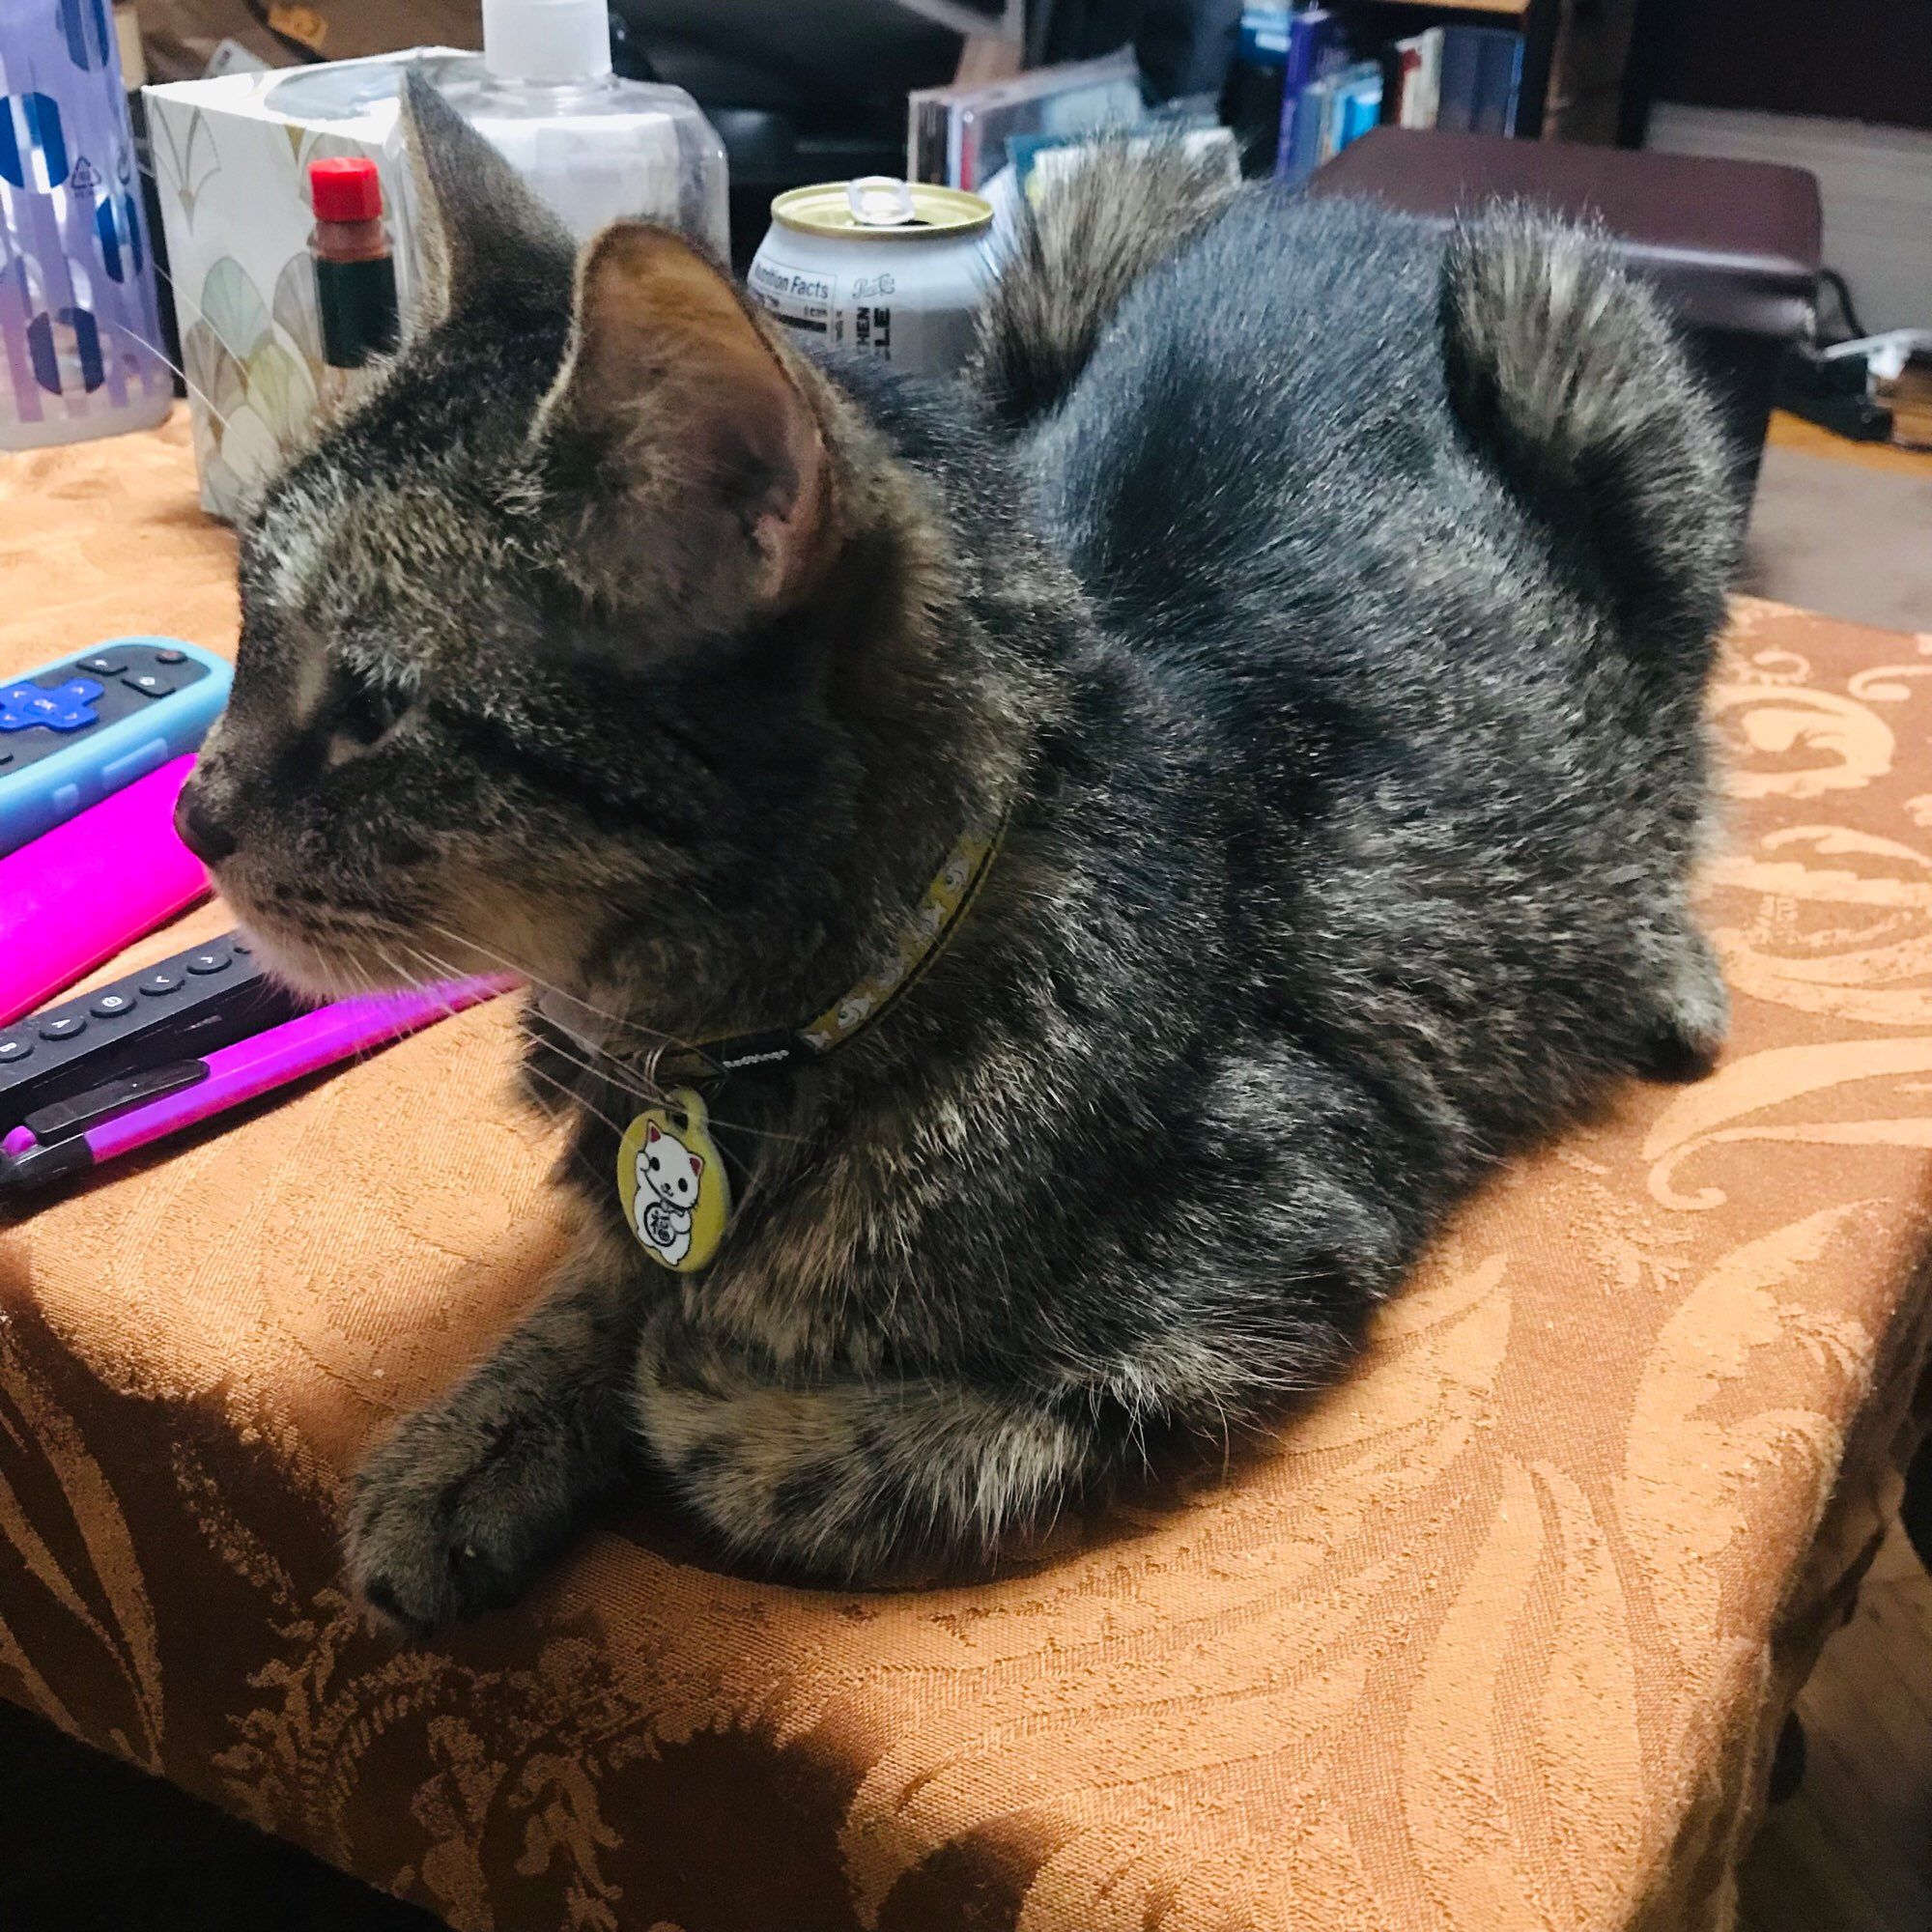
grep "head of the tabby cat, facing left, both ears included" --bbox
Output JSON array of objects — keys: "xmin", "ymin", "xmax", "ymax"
[{"xmin": 178, "ymin": 83, "xmax": 966, "ymax": 1020}]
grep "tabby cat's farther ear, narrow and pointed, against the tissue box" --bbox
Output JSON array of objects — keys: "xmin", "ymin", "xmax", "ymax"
[{"xmin": 402, "ymin": 64, "xmax": 576, "ymax": 328}]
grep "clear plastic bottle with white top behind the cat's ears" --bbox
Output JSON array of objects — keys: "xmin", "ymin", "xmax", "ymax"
[{"xmin": 442, "ymin": 0, "xmax": 730, "ymax": 259}]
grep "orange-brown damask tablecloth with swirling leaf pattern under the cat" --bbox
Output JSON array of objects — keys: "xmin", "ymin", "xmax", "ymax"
[{"xmin": 0, "ymin": 421, "xmax": 1932, "ymax": 1932}]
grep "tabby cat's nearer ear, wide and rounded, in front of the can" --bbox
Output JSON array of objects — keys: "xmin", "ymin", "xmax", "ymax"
[{"xmin": 543, "ymin": 222, "xmax": 835, "ymax": 611}]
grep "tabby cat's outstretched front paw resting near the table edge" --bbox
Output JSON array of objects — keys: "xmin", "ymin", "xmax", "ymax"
[{"xmin": 344, "ymin": 1410, "xmax": 564, "ymax": 1636}]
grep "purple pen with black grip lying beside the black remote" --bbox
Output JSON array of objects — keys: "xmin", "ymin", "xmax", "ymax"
[{"xmin": 0, "ymin": 976, "xmax": 518, "ymax": 1198}]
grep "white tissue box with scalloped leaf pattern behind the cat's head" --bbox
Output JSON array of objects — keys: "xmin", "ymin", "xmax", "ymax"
[{"xmin": 145, "ymin": 48, "xmax": 464, "ymax": 522}]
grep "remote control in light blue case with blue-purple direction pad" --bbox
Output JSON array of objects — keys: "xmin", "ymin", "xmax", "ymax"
[{"xmin": 0, "ymin": 638, "xmax": 234, "ymax": 854}]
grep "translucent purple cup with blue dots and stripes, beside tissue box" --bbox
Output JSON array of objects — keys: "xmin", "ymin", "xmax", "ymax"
[{"xmin": 0, "ymin": 0, "xmax": 174, "ymax": 450}]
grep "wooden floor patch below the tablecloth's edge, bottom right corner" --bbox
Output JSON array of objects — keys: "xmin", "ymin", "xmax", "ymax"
[{"xmin": 1739, "ymin": 1530, "xmax": 1932, "ymax": 1932}]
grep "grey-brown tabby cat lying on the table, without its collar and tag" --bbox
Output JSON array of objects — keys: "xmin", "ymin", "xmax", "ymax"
[{"xmin": 182, "ymin": 83, "xmax": 1737, "ymax": 1629}]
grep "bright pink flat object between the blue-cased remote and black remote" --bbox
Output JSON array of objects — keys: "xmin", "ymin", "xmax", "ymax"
[{"xmin": 0, "ymin": 755, "xmax": 209, "ymax": 1026}]
